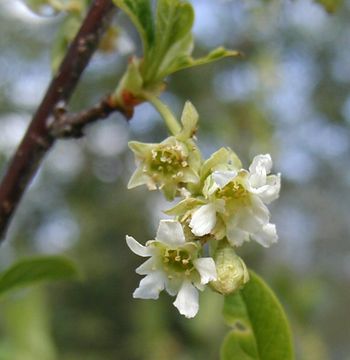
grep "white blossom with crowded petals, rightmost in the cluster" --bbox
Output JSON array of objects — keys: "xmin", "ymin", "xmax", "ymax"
[{"xmin": 167, "ymin": 149, "xmax": 281, "ymax": 247}]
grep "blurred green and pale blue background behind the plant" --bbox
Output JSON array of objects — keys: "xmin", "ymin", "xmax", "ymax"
[{"xmin": 0, "ymin": 0, "xmax": 350, "ymax": 360}]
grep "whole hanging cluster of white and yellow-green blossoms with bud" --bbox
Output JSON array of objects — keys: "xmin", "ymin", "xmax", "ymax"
[{"xmin": 126, "ymin": 102, "xmax": 281, "ymax": 318}]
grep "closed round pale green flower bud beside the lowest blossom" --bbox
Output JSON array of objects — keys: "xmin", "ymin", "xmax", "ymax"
[{"xmin": 210, "ymin": 239, "xmax": 249, "ymax": 295}]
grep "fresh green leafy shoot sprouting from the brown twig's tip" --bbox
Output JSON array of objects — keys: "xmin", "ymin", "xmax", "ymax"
[{"xmin": 114, "ymin": 0, "xmax": 239, "ymax": 105}]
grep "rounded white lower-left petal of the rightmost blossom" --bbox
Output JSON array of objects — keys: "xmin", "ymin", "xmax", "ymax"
[{"xmin": 190, "ymin": 204, "xmax": 216, "ymax": 236}]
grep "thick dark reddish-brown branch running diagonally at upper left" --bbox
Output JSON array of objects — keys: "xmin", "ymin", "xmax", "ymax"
[{"xmin": 0, "ymin": 0, "xmax": 116, "ymax": 242}]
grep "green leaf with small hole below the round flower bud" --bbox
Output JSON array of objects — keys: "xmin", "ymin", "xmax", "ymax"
[{"xmin": 221, "ymin": 271, "xmax": 294, "ymax": 360}]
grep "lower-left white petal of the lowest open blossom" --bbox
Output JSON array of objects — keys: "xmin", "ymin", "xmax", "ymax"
[{"xmin": 133, "ymin": 271, "xmax": 167, "ymax": 299}]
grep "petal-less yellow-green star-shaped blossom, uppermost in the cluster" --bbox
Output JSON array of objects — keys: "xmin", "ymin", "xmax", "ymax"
[{"xmin": 128, "ymin": 102, "xmax": 201, "ymax": 200}]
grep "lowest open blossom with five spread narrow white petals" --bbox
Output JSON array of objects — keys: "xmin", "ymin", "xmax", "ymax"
[{"xmin": 126, "ymin": 220, "xmax": 216, "ymax": 318}]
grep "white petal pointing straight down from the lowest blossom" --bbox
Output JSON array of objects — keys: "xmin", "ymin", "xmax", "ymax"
[{"xmin": 173, "ymin": 280, "xmax": 199, "ymax": 318}]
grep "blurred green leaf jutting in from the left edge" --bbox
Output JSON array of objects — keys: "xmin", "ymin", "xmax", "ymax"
[{"xmin": 0, "ymin": 256, "xmax": 77, "ymax": 295}]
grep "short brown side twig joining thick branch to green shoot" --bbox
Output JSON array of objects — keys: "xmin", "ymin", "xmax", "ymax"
[{"xmin": 49, "ymin": 95, "xmax": 132, "ymax": 138}]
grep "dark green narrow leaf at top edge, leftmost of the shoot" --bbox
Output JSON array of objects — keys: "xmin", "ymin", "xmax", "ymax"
[{"xmin": 114, "ymin": 0, "xmax": 154, "ymax": 54}]
